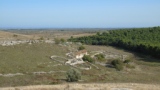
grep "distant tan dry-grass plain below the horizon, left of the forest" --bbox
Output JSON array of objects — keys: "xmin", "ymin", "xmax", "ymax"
[{"xmin": 0, "ymin": 30, "xmax": 96, "ymax": 40}]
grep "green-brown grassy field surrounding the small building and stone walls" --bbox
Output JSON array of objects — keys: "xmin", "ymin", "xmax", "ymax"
[{"xmin": 0, "ymin": 43, "xmax": 160, "ymax": 87}]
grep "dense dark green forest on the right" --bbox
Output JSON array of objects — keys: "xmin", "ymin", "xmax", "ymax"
[{"xmin": 69, "ymin": 27, "xmax": 160, "ymax": 58}]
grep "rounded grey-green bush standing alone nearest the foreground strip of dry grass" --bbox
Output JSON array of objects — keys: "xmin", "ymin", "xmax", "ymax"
[{"xmin": 66, "ymin": 69, "xmax": 81, "ymax": 82}]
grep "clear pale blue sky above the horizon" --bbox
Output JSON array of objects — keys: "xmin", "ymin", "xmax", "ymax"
[{"xmin": 0, "ymin": 0, "xmax": 160, "ymax": 28}]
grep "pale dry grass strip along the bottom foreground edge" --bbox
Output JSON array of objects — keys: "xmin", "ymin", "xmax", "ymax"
[{"xmin": 0, "ymin": 83, "xmax": 160, "ymax": 90}]
